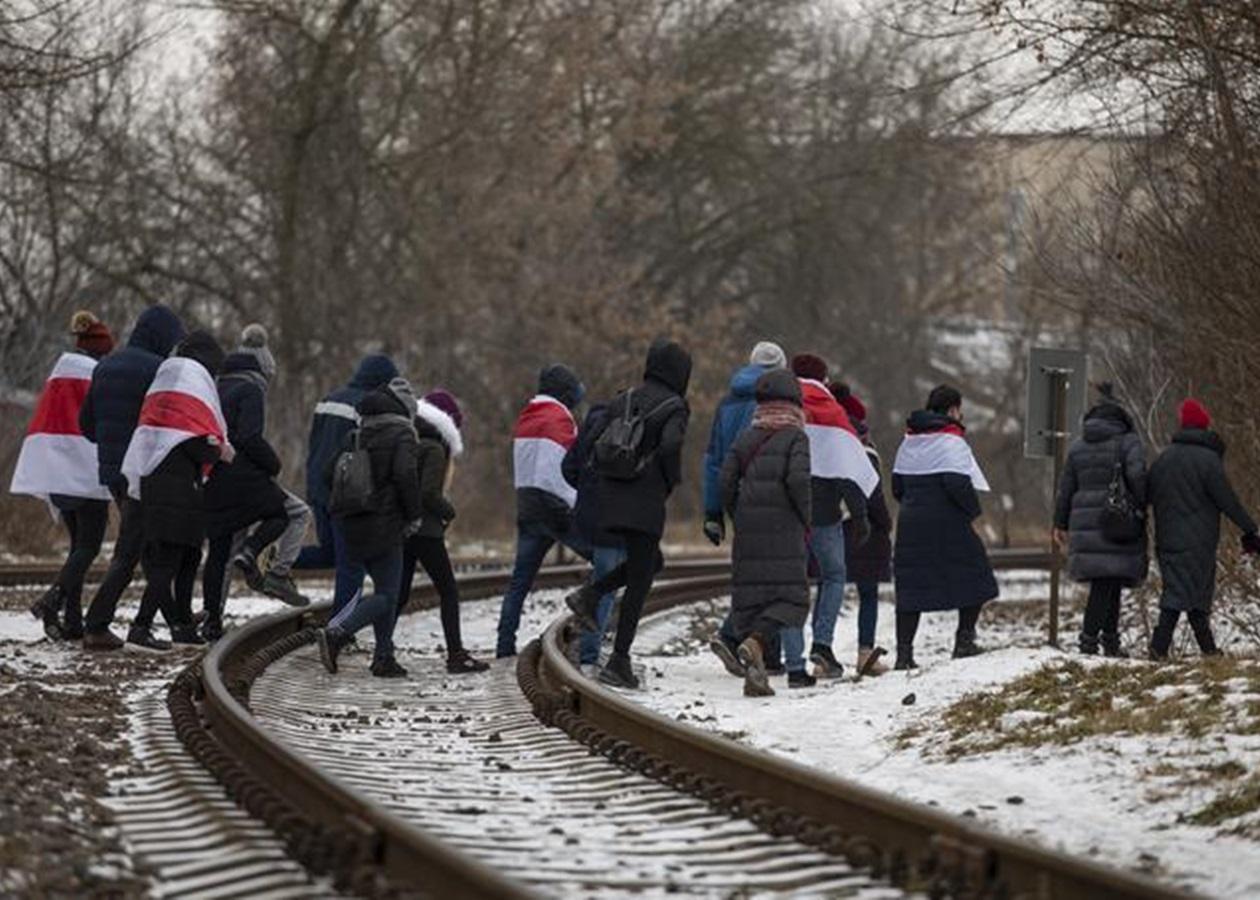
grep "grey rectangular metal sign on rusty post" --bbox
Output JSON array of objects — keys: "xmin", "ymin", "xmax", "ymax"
[{"xmin": 1024, "ymin": 347, "xmax": 1089, "ymax": 459}]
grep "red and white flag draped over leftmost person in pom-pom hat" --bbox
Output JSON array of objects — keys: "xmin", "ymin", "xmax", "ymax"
[{"xmin": 9, "ymin": 353, "xmax": 110, "ymax": 500}]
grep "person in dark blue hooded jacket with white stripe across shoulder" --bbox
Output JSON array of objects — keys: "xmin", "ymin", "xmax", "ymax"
[{"xmin": 294, "ymin": 353, "xmax": 398, "ymax": 611}]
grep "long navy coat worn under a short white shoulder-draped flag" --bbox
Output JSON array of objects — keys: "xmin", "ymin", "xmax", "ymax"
[{"xmin": 892, "ymin": 410, "xmax": 998, "ymax": 613}]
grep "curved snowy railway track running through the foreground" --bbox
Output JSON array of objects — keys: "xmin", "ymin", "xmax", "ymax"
[{"xmin": 137, "ymin": 555, "xmax": 1183, "ymax": 899}]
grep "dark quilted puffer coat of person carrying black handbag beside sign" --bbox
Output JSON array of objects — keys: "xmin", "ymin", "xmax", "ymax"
[{"xmin": 1055, "ymin": 403, "xmax": 1149, "ymax": 587}]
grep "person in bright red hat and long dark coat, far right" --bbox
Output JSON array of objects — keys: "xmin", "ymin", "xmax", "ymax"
[{"xmin": 1150, "ymin": 400, "xmax": 1260, "ymax": 659}]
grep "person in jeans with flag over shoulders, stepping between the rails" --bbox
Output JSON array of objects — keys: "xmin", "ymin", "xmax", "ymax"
[{"xmin": 494, "ymin": 364, "xmax": 591, "ymax": 659}]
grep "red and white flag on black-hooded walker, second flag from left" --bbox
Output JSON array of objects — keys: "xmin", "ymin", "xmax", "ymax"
[{"xmin": 122, "ymin": 357, "xmax": 228, "ymax": 499}]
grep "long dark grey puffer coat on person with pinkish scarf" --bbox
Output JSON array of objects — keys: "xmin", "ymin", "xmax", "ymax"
[{"xmin": 722, "ymin": 371, "xmax": 810, "ymax": 637}]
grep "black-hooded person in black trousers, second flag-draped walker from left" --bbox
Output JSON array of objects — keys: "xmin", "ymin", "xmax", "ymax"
[{"xmin": 122, "ymin": 332, "xmax": 234, "ymax": 650}]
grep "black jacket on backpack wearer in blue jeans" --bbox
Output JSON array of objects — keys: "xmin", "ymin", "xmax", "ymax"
[{"xmin": 324, "ymin": 387, "xmax": 423, "ymax": 562}]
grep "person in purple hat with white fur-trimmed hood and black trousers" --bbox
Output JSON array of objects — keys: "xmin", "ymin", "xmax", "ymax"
[{"xmin": 398, "ymin": 388, "xmax": 490, "ymax": 674}]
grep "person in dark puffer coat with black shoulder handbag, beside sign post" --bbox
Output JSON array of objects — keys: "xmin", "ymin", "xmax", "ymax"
[{"xmin": 1055, "ymin": 384, "xmax": 1149, "ymax": 657}]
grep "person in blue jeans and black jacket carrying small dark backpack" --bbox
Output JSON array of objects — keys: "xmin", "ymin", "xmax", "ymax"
[{"xmin": 316, "ymin": 378, "xmax": 425, "ymax": 678}]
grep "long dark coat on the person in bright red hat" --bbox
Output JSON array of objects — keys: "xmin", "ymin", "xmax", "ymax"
[{"xmin": 1148, "ymin": 429, "xmax": 1256, "ymax": 611}]
